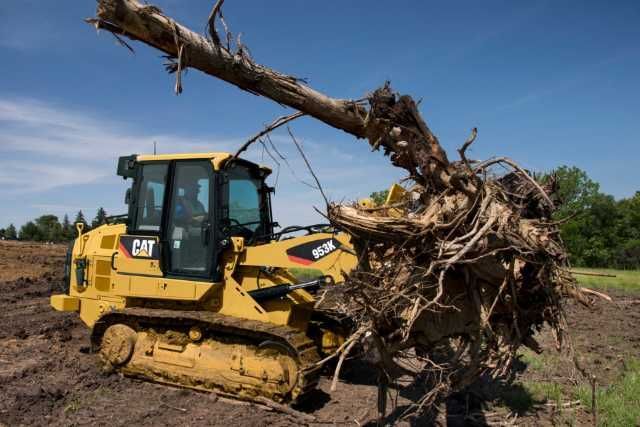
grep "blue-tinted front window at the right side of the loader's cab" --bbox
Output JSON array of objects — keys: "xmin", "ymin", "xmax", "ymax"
[{"xmin": 229, "ymin": 167, "xmax": 262, "ymax": 232}]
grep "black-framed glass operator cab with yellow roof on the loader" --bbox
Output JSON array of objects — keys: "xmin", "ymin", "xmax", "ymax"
[{"xmin": 118, "ymin": 153, "xmax": 275, "ymax": 281}]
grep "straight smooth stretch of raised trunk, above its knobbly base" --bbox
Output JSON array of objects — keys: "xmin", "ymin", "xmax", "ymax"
[{"xmin": 92, "ymin": 0, "xmax": 366, "ymax": 138}]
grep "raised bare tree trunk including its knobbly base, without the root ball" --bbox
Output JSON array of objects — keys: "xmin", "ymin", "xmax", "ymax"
[{"xmin": 88, "ymin": 0, "xmax": 456, "ymax": 191}]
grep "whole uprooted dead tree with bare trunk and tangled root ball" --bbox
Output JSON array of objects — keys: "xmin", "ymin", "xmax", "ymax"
[{"xmin": 88, "ymin": 0, "xmax": 587, "ymax": 420}]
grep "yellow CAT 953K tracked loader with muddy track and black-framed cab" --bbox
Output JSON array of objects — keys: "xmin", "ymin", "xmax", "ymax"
[{"xmin": 51, "ymin": 153, "xmax": 370, "ymax": 403}]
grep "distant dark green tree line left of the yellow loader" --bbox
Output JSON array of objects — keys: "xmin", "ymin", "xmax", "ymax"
[{"xmin": 0, "ymin": 208, "xmax": 107, "ymax": 242}]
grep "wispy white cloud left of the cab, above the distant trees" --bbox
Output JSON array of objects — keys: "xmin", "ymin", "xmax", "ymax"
[{"xmin": 0, "ymin": 99, "xmax": 240, "ymax": 192}]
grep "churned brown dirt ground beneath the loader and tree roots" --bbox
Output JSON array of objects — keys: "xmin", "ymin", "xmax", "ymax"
[{"xmin": 0, "ymin": 242, "xmax": 640, "ymax": 426}]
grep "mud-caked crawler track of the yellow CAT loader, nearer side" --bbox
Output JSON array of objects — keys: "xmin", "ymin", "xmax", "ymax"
[{"xmin": 91, "ymin": 308, "xmax": 321, "ymax": 403}]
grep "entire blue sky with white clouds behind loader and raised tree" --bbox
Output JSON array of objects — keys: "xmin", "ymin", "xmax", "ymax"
[{"xmin": 0, "ymin": 0, "xmax": 640, "ymax": 226}]
